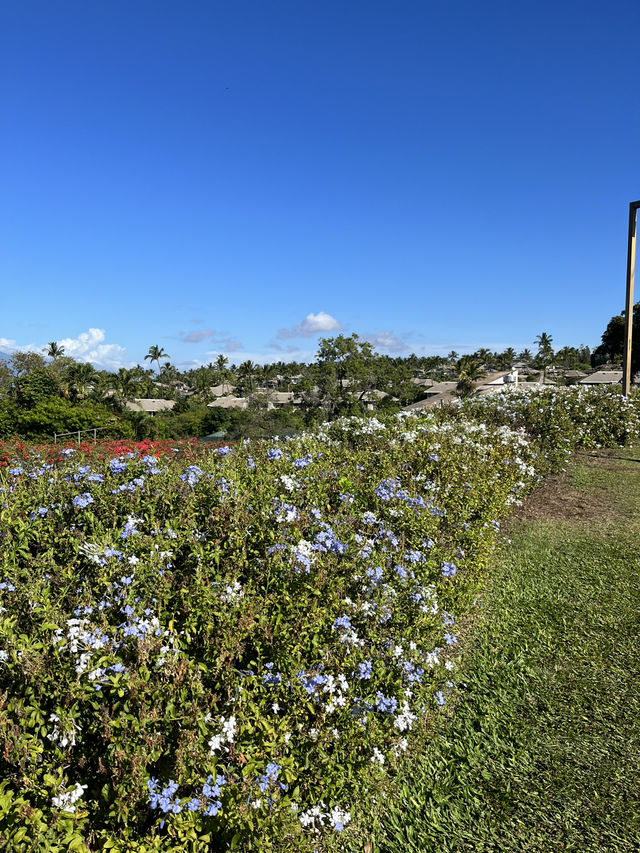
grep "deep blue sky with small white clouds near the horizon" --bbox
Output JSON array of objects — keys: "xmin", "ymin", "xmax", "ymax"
[{"xmin": 0, "ymin": 0, "xmax": 640, "ymax": 367}]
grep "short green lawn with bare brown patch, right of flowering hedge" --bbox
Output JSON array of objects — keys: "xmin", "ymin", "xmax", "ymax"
[{"xmin": 374, "ymin": 450, "xmax": 640, "ymax": 853}]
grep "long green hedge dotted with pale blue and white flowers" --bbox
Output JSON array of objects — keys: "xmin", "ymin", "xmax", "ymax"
[{"xmin": 0, "ymin": 391, "xmax": 640, "ymax": 853}]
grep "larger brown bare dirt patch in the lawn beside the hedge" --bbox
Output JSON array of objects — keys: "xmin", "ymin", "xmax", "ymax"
[{"xmin": 504, "ymin": 474, "xmax": 613, "ymax": 522}]
